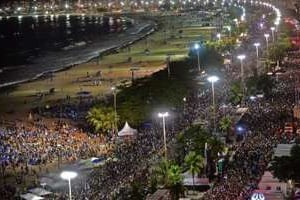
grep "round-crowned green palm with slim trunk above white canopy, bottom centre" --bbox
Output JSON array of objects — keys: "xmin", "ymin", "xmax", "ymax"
[{"xmin": 184, "ymin": 151, "xmax": 204, "ymax": 190}]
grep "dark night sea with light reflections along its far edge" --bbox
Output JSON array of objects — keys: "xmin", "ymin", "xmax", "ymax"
[{"xmin": 0, "ymin": 15, "xmax": 155, "ymax": 87}]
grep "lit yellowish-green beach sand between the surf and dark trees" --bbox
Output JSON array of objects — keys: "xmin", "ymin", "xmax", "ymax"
[{"xmin": 0, "ymin": 17, "xmax": 210, "ymax": 119}]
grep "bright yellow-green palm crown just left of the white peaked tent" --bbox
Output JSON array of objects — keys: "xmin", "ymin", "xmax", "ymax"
[{"xmin": 86, "ymin": 107, "xmax": 115, "ymax": 133}]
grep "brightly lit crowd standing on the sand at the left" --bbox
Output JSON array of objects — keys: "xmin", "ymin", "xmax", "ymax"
[{"xmin": 0, "ymin": 120, "xmax": 106, "ymax": 184}]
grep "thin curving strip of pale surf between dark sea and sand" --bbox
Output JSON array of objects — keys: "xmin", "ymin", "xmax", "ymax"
[{"xmin": 0, "ymin": 19, "xmax": 157, "ymax": 92}]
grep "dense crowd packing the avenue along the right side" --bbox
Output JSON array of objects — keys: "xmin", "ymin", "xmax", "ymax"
[{"xmin": 204, "ymin": 12, "xmax": 299, "ymax": 200}]
